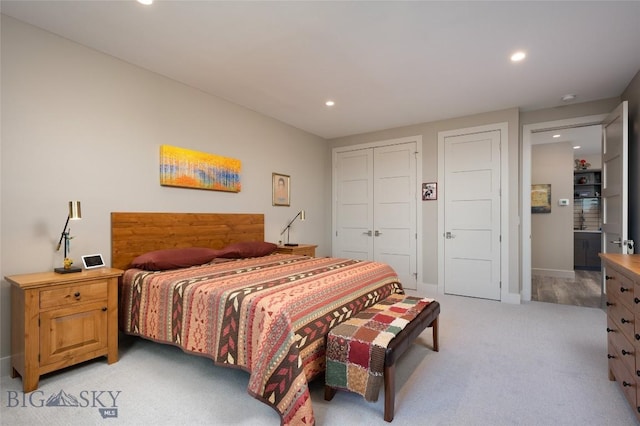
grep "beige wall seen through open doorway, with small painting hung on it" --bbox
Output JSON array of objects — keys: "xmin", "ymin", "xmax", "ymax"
[{"xmin": 531, "ymin": 142, "xmax": 573, "ymax": 276}]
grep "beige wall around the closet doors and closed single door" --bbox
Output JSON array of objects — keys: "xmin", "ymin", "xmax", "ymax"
[{"xmin": 330, "ymin": 108, "xmax": 520, "ymax": 300}]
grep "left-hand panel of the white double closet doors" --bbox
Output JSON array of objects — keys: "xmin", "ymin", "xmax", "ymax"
[{"xmin": 333, "ymin": 149, "xmax": 374, "ymax": 260}]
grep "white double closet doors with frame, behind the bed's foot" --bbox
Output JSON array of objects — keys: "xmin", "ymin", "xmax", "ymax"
[{"xmin": 333, "ymin": 142, "xmax": 419, "ymax": 290}]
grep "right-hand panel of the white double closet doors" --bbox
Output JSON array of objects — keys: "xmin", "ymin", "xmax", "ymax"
[{"xmin": 373, "ymin": 142, "xmax": 418, "ymax": 290}]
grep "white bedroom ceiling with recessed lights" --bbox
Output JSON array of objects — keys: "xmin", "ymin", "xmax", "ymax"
[{"xmin": 0, "ymin": 0, "xmax": 640, "ymax": 138}]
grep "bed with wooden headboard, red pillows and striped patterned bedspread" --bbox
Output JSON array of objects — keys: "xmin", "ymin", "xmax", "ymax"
[{"xmin": 111, "ymin": 213, "xmax": 403, "ymax": 425}]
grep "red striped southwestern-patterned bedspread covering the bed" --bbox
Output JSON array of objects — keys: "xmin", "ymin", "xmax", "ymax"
[{"xmin": 119, "ymin": 254, "xmax": 403, "ymax": 425}]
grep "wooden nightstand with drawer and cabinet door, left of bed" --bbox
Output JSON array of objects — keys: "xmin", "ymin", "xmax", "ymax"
[{"xmin": 5, "ymin": 268, "xmax": 123, "ymax": 392}]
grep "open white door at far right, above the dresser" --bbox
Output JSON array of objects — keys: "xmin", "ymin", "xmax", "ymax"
[{"xmin": 602, "ymin": 101, "xmax": 632, "ymax": 255}]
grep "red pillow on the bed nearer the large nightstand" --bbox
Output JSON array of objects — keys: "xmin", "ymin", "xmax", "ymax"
[{"xmin": 131, "ymin": 247, "xmax": 220, "ymax": 271}]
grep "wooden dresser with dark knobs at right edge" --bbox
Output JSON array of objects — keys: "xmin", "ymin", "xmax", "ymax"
[{"xmin": 600, "ymin": 253, "xmax": 640, "ymax": 420}]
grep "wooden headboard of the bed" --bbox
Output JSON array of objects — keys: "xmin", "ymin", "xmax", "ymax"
[{"xmin": 111, "ymin": 212, "xmax": 264, "ymax": 269}]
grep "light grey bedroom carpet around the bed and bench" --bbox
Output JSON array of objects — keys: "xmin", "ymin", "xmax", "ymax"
[{"xmin": 0, "ymin": 295, "xmax": 638, "ymax": 426}]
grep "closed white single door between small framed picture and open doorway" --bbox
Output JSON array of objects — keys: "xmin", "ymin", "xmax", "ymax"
[{"xmin": 442, "ymin": 130, "xmax": 501, "ymax": 300}]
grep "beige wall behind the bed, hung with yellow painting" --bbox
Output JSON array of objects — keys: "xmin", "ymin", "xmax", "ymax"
[{"xmin": 0, "ymin": 16, "xmax": 331, "ymax": 371}]
